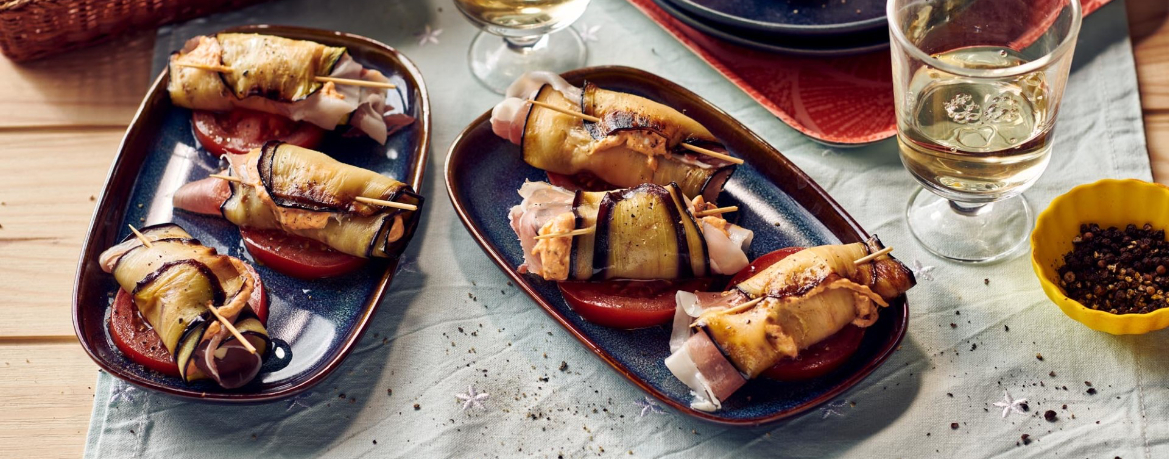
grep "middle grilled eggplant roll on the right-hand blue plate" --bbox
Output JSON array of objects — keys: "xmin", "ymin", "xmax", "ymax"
[{"xmin": 509, "ymin": 182, "xmax": 754, "ymax": 280}]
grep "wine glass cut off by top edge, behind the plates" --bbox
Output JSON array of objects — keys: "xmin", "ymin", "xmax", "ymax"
[{"xmin": 455, "ymin": 0, "xmax": 589, "ymax": 93}]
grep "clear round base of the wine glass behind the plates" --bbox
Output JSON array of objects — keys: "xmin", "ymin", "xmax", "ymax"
[{"xmin": 466, "ymin": 27, "xmax": 588, "ymax": 95}]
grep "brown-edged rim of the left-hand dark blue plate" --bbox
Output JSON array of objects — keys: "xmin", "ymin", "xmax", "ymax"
[{"xmin": 71, "ymin": 23, "xmax": 433, "ymax": 403}]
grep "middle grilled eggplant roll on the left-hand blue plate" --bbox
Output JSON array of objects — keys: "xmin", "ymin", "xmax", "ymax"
[{"xmin": 174, "ymin": 141, "xmax": 423, "ymax": 258}]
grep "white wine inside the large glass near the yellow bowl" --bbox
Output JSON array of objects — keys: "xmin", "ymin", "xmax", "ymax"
[{"xmin": 898, "ymin": 47, "xmax": 1052, "ymax": 202}]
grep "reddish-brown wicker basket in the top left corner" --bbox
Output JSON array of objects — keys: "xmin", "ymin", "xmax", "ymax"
[{"xmin": 0, "ymin": 0, "xmax": 264, "ymax": 61}]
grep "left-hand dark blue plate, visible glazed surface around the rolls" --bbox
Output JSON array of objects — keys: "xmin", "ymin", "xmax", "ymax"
[{"xmin": 74, "ymin": 26, "xmax": 430, "ymax": 402}]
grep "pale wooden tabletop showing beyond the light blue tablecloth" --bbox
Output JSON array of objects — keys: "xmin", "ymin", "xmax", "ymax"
[{"xmin": 0, "ymin": 0, "xmax": 1169, "ymax": 458}]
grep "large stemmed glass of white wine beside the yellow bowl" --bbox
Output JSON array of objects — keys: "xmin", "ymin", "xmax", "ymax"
[{"xmin": 886, "ymin": 0, "xmax": 1081, "ymax": 263}]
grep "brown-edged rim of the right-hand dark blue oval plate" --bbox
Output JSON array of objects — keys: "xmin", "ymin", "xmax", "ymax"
[{"xmin": 443, "ymin": 65, "xmax": 909, "ymax": 426}]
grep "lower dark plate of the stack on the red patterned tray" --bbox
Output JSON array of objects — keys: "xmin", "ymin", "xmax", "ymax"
[{"xmin": 652, "ymin": 0, "xmax": 888, "ymax": 57}]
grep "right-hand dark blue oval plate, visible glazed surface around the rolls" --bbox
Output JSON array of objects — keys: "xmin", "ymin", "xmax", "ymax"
[{"xmin": 447, "ymin": 67, "xmax": 908, "ymax": 425}]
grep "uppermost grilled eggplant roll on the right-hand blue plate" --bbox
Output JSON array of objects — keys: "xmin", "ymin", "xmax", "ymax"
[{"xmin": 491, "ymin": 72, "xmax": 734, "ymax": 201}]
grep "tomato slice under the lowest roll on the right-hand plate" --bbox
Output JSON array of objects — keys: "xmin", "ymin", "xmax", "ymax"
[{"xmin": 727, "ymin": 248, "xmax": 865, "ymax": 381}]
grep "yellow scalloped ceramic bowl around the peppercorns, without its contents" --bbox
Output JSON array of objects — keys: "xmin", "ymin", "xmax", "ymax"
[{"xmin": 1031, "ymin": 180, "xmax": 1169, "ymax": 335}]
